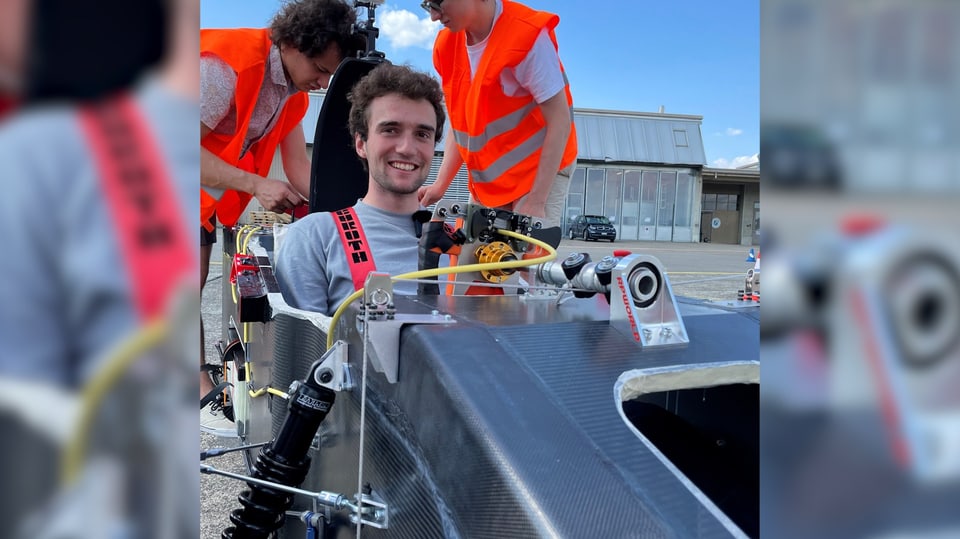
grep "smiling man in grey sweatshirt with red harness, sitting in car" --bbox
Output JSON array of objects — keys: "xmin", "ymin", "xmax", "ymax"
[{"xmin": 275, "ymin": 63, "xmax": 445, "ymax": 316}]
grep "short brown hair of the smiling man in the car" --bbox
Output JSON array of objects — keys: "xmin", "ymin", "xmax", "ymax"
[{"xmin": 347, "ymin": 62, "xmax": 447, "ymax": 142}]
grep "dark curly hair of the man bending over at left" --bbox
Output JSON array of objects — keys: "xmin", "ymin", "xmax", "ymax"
[{"xmin": 270, "ymin": 0, "xmax": 365, "ymax": 58}]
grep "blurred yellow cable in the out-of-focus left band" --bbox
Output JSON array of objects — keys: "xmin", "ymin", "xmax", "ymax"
[{"xmin": 61, "ymin": 318, "xmax": 168, "ymax": 485}]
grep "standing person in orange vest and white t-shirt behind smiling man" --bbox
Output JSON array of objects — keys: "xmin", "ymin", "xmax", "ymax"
[{"xmin": 420, "ymin": 0, "xmax": 577, "ymax": 227}]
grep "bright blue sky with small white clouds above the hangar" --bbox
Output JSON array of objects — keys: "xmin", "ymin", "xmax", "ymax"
[{"xmin": 200, "ymin": 0, "xmax": 760, "ymax": 167}]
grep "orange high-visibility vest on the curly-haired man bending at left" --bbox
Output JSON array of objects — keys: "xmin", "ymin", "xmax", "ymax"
[{"xmin": 200, "ymin": 28, "xmax": 309, "ymax": 230}]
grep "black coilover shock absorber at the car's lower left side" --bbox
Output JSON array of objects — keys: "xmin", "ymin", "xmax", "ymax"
[{"xmin": 221, "ymin": 361, "xmax": 336, "ymax": 539}]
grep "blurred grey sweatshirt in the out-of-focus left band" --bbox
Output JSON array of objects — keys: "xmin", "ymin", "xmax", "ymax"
[{"xmin": 0, "ymin": 79, "xmax": 200, "ymax": 386}]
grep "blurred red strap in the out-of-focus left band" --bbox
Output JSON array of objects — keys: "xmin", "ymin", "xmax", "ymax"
[{"xmin": 80, "ymin": 94, "xmax": 196, "ymax": 321}]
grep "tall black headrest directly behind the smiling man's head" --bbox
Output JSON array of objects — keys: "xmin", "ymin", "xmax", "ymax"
[{"xmin": 310, "ymin": 56, "xmax": 385, "ymax": 213}]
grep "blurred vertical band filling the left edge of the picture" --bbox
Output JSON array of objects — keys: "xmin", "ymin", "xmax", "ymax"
[{"xmin": 0, "ymin": 0, "xmax": 200, "ymax": 538}]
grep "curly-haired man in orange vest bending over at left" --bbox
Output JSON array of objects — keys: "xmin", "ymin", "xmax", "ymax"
[{"xmin": 200, "ymin": 0, "xmax": 362, "ymax": 436}]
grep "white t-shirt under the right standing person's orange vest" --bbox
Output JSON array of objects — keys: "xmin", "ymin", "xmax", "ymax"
[{"xmin": 467, "ymin": 0, "xmax": 566, "ymax": 103}]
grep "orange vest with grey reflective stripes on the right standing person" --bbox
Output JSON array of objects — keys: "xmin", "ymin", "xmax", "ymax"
[{"xmin": 433, "ymin": 0, "xmax": 577, "ymax": 207}]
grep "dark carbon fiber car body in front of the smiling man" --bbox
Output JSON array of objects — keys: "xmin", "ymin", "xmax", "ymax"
[{"xmin": 251, "ymin": 296, "xmax": 759, "ymax": 538}]
